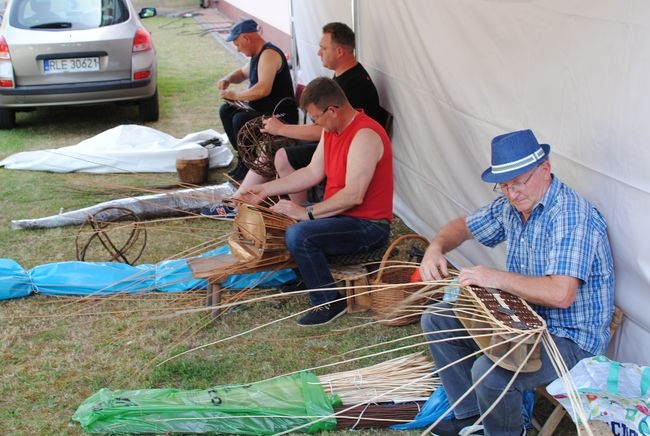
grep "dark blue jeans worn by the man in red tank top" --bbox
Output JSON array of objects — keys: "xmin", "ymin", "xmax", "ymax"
[{"xmin": 285, "ymin": 215, "xmax": 390, "ymax": 306}]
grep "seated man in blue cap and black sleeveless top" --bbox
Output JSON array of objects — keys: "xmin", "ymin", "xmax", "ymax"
[{"xmin": 217, "ymin": 19, "xmax": 298, "ymax": 181}]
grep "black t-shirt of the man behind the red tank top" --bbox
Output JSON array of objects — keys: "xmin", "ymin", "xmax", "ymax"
[{"xmin": 334, "ymin": 63, "xmax": 381, "ymax": 123}]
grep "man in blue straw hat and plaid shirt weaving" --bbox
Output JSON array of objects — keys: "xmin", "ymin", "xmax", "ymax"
[{"xmin": 420, "ymin": 130, "xmax": 614, "ymax": 436}]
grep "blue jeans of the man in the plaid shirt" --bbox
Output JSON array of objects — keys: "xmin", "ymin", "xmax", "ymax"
[{"xmin": 421, "ymin": 303, "xmax": 591, "ymax": 436}]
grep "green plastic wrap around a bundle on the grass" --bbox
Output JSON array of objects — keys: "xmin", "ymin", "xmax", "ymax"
[{"xmin": 72, "ymin": 372, "xmax": 340, "ymax": 435}]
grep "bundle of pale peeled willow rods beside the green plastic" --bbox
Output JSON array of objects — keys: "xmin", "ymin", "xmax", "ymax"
[{"xmin": 319, "ymin": 352, "xmax": 440, "ymax": 405}]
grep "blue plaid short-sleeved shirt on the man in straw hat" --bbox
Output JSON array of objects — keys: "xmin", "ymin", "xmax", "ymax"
[{"xmin": 467, "ymin": 176, "xmax": 614, "ymax": 354}]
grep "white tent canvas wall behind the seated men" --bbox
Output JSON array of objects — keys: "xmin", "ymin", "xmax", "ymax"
[{"xmin": 292, "ymin": 0, "xmax": 650, "ymax": 365}]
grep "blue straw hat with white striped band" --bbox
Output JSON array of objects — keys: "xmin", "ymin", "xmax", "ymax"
[{"xmin": 481, "ymin": 130, "xmax": 551, "ymax": 183}]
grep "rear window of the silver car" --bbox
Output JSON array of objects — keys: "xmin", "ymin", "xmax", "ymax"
[{"xmin": 10, "ymin": 0, "xmax": 129, "ymax": 29}]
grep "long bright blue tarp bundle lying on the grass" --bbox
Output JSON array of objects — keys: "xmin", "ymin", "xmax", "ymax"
[{"xmin": 0, "ymin": 246, "xmax": 296, "ymax": 300}]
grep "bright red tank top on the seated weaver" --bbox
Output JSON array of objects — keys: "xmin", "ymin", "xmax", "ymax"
[{"xmin": 323, "ymin": 112, "xmax": 393, "ymax": 222}]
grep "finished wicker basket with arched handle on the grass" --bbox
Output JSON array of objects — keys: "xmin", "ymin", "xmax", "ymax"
[{"xmin": 372, "ymin": 234, "xmax": 429, "ymax": 326}]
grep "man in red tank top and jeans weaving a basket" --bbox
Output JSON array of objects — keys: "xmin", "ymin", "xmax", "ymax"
[{"xmin": 242, "ymin": 77, "xmax": 393, "ymax": 326}]
